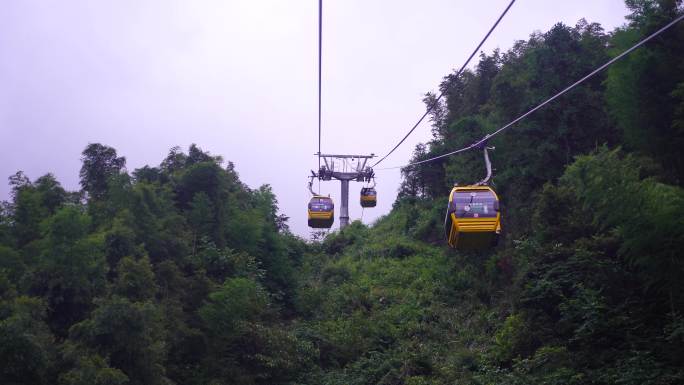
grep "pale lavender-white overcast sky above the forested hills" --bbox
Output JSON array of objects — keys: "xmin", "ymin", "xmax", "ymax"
[{"xmin": 0, "ymin": 0, "xmax": 627, "ymax": 236}]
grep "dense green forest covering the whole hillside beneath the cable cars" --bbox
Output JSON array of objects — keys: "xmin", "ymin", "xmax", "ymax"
[{"xmin": 0, "ymin": 0, "xmax": 684, "ymax": 385}]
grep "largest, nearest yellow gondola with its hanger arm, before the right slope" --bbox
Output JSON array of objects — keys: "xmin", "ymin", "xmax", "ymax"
[{"xmin": 444, "ymin": 146, "xmax": 501, "ymax": 250}]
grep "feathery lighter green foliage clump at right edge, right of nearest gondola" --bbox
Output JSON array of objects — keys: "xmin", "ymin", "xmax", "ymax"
[{"xmin": 562, "ymin": 150, "xmax": 684, "ymax": 292}]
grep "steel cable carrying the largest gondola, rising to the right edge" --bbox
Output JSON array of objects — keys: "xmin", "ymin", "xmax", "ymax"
[{"xmin": 376, "ymin": 14, "xmax": 684, "ymax": 171}]
